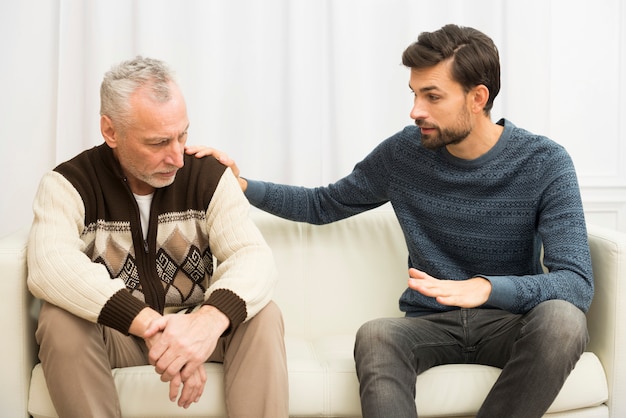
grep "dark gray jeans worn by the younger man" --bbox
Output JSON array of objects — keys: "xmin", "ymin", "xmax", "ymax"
[{"xmin": 354, "ymin": 300, "xmax": 589, "ymax": 418}]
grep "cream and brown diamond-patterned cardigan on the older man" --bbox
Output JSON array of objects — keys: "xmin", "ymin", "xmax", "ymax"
[{"xmin": 28, "ymin": 144, "xmax": 275, "ymax": 332}]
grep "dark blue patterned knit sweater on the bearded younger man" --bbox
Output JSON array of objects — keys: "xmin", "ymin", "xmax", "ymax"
[{"xmin": 246, "ymin": 120, "xmax": 593, "ymax": 316}]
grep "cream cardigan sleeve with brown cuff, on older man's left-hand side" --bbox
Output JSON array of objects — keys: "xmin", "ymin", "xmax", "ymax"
[{"xmin": 27, "ymin": 172, "xmax": 145, "ymax": 324}]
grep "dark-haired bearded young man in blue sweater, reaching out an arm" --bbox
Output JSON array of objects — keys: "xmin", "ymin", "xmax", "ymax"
[{"xmin": 189, "ymin": 25, "xmax": 593, "ymax": 418}]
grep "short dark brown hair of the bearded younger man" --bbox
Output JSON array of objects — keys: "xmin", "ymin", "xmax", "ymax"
[{"xmin": 402, "ymin": 25, "xmax": 500, "ymax": 115}]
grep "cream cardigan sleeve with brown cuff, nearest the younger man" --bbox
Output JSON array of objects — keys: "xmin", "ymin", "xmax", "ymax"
[{"xmin": 205, "ymin": 169, "xmax": 277, "ymax": 327}]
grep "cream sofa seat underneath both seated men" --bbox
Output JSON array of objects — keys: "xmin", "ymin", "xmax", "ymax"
[{"xmin": 29, "ymin": 335, "xmax": 608, "ymax": 418}]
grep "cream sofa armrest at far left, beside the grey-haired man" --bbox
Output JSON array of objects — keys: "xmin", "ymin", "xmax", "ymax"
[{"xmin": 0, "ymin": 227, "xmax": 36, "ymax": 418}]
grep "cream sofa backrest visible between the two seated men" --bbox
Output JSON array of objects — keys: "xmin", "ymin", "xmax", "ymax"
[{"xmin": 251, "ymin": 208, "xmax": 408, "ymax": 338}]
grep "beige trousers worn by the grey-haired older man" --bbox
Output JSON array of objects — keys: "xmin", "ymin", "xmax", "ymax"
[{"xmin": 36, "ymin": 302, "xmax": 289, "ymax": 418}]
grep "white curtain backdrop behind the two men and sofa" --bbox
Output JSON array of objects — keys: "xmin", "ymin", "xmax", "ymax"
[{"xmin": 0, "ymin": 0, "xmax": 626, "ymax": 236}]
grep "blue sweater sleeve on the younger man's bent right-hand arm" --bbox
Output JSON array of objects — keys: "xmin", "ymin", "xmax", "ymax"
[{"xmin": 483, "ymin": 149, "xmax": 594, "ymax": 313}]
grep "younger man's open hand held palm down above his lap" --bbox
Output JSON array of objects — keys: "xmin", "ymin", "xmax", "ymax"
[{"xmin": 409, "ymin": 268, "xmax": 491, "ymax": 308}]
